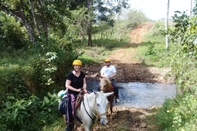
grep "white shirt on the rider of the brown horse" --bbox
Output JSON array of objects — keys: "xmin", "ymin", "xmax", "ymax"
[{"xmin": 100, "ymin": 65, "xmax": 116, "ymax": 78}]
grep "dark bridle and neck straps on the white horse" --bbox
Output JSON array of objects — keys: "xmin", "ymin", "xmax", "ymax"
[{"xmin": 83, "ymin": 92, "xmax": 107, "ymax": 120}]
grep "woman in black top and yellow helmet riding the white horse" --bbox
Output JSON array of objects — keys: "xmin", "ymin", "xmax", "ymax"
[{"xmin": 65, "ymin": 60, "xmax": 87, "ymax": 131}]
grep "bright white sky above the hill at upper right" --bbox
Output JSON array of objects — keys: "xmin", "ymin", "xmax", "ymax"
[{"xmin": 129, "ymin": 0, "xmax": 194, "ymax": 20}]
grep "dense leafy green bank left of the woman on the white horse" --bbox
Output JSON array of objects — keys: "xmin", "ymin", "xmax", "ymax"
[{"xmin": 0, "ymin": 37, "xmax": 78, "ymax": 131}]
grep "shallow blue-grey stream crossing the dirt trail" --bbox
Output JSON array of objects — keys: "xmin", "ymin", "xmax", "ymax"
[{"xmin": 87, "ymin": 81, "xmax": 176, "ymax": 108}]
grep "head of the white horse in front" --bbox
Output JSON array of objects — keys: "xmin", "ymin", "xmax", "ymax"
[{"xmin": 95, "ymin": 92, "xmax": 113, "ymax": 125}]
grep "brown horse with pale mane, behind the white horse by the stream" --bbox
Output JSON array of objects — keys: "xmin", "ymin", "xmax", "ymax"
[{"xmin": 99, "ymin": 77, "xmax": 114, "ymax": 114}]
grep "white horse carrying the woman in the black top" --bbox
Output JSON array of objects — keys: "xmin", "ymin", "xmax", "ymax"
[{"xmin": 76, "ymin": 92, "xmax": 113, "ymax": 131}]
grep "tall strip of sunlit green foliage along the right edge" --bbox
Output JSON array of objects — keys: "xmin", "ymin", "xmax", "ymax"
[{"xmin": 158, "ymin": 3, "xmax": 197, "ymax": 131}]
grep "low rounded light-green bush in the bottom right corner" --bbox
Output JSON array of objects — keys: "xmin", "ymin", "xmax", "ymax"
[{"xmin": 157, "ymin": 94, "xmax": 197, "ymax": 131}]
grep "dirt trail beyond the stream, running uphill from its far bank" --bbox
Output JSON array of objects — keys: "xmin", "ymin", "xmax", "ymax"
[{"xmin": 84, "ymin": 22, "xmax": 173, "ymax": 83}]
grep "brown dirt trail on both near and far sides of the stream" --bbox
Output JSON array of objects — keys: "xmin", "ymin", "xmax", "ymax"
[{"xmin": 79, "ymin": 22, "xmax": 173, "ymax": 131}]
